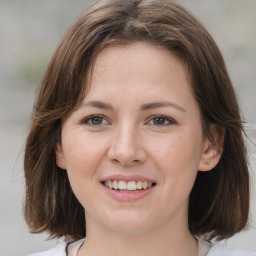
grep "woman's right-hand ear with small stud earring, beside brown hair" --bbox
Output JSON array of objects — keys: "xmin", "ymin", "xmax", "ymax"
[{"xmin": 198, "ymin": 124, "xmax": 225, "ymax": 171}]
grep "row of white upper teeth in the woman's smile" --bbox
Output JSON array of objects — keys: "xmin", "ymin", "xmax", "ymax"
[{"xmin": 104, "ymin": 180, "xmax": 153, "ymax": 192}]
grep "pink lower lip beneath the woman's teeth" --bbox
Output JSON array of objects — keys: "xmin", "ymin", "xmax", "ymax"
[{"xmin": 101, "ymin": 184, "xmax": 155, "ymax": 201}]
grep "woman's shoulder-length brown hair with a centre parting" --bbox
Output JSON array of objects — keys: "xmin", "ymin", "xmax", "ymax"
[{"xmin": 24, "ymin": 0, "xmax": 249, "ymax": 239}]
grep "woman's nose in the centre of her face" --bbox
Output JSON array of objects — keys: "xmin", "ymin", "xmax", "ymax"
[{"xmin": 108, "ymin": 125, "xmax": 147, "ymax": 167}]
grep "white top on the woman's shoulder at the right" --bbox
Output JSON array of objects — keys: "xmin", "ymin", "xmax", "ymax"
[{"xmin": 207, "ymin": 243, "xmax": 256, "ymax": 256}]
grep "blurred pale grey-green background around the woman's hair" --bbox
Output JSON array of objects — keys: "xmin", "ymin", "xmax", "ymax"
[{"xmin": 0, "ymin": 0, "xmax": 256, "ymax": 256}]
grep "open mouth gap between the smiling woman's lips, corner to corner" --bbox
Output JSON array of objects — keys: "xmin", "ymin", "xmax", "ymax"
[{"xmin": 101, "ymin": 180, "xmax": 156, "ymax": 193}]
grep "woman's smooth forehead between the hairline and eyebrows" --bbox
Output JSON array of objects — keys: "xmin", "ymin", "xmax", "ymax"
[{"xmin": 79, "ymin": 42, "xmax": 198, "ymax": 115}]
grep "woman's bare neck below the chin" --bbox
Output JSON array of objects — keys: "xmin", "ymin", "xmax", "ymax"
[{"xmin": 79, "ymin": 214, "xmax": 198, "ymax": 256}]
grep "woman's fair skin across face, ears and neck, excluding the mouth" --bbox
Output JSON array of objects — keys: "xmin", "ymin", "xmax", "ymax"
[{"xmin": 56, "ymin": 43, "xmax": 220, "ymax": 256}]
